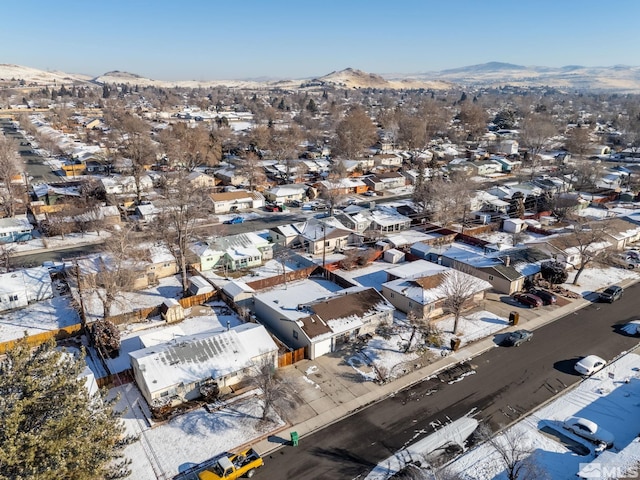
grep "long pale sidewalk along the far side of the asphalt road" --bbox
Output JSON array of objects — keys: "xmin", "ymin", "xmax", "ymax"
[{"xmin": 253, "ymin": 280, "xmax": 616, "ymax": 454}]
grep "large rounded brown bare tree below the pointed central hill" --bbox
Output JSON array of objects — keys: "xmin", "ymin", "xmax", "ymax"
[{"xmin": 334, "ymin": 106, "xmax": 377, "ymax": 158}]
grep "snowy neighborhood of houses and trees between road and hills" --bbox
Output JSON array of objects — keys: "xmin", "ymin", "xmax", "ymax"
[{"xmin": 0, "ymin": 68, "xmax": 640, "ymax": 478}]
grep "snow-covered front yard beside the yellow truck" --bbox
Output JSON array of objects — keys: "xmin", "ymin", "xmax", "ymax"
[{"xmin": 111, "ymin": 384, "xmax": 285, "ymax": 480}]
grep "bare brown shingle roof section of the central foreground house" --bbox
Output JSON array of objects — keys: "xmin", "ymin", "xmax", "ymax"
[{"xmin": 301, "ymin": 288, "xmax": 386, "ymax": 338}]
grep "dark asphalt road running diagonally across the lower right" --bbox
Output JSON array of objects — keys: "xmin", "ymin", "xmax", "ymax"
[{"xmin": 256, "ymin": 285, "xmax": 640, "ymax": 480}]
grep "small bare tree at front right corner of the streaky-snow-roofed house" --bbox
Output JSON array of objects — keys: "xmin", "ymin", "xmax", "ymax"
[{"xmin": 248, "ymin": 356, "xmax": 297, "ymax": 420}]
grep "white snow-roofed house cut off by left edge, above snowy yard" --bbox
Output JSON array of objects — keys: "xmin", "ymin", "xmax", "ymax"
[{"xmin": 0, "ymin": 267, "xmax": 53, "ymax": 311}]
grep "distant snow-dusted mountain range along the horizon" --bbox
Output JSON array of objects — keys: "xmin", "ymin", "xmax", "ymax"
[{"xmin": 0, "ymin": 62, "xmax": 640, "ymax": 93}]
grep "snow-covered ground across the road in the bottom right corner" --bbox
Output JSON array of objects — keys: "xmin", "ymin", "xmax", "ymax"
[{"xmin": 448, "ymin": 353, "xmax": 640, "ymax": 480}]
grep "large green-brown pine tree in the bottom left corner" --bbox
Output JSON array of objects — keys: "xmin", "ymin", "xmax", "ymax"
[{"xmin": 0, "ymin": 339, "xmax": 133, "ymax": 480}]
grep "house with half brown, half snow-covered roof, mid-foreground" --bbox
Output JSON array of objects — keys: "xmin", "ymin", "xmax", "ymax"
[{"xmin": 253, "ymin": 280, "xmax": 393, "ymax": 360}]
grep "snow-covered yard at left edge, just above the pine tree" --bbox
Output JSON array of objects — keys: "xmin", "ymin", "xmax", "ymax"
[{"xmin": 0, "ymin": 297, "xmax": 80, "ymax": 342}]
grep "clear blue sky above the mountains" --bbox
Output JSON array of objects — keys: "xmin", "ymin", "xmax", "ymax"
[{"xmin": 5, "ymin": 0, "xmax": 640, "ymax": 80}]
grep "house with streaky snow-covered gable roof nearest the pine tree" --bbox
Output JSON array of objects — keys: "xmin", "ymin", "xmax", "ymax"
[{"xmin": 129, "ymin": 323, "xmax": 278, "ymax": 406}]
